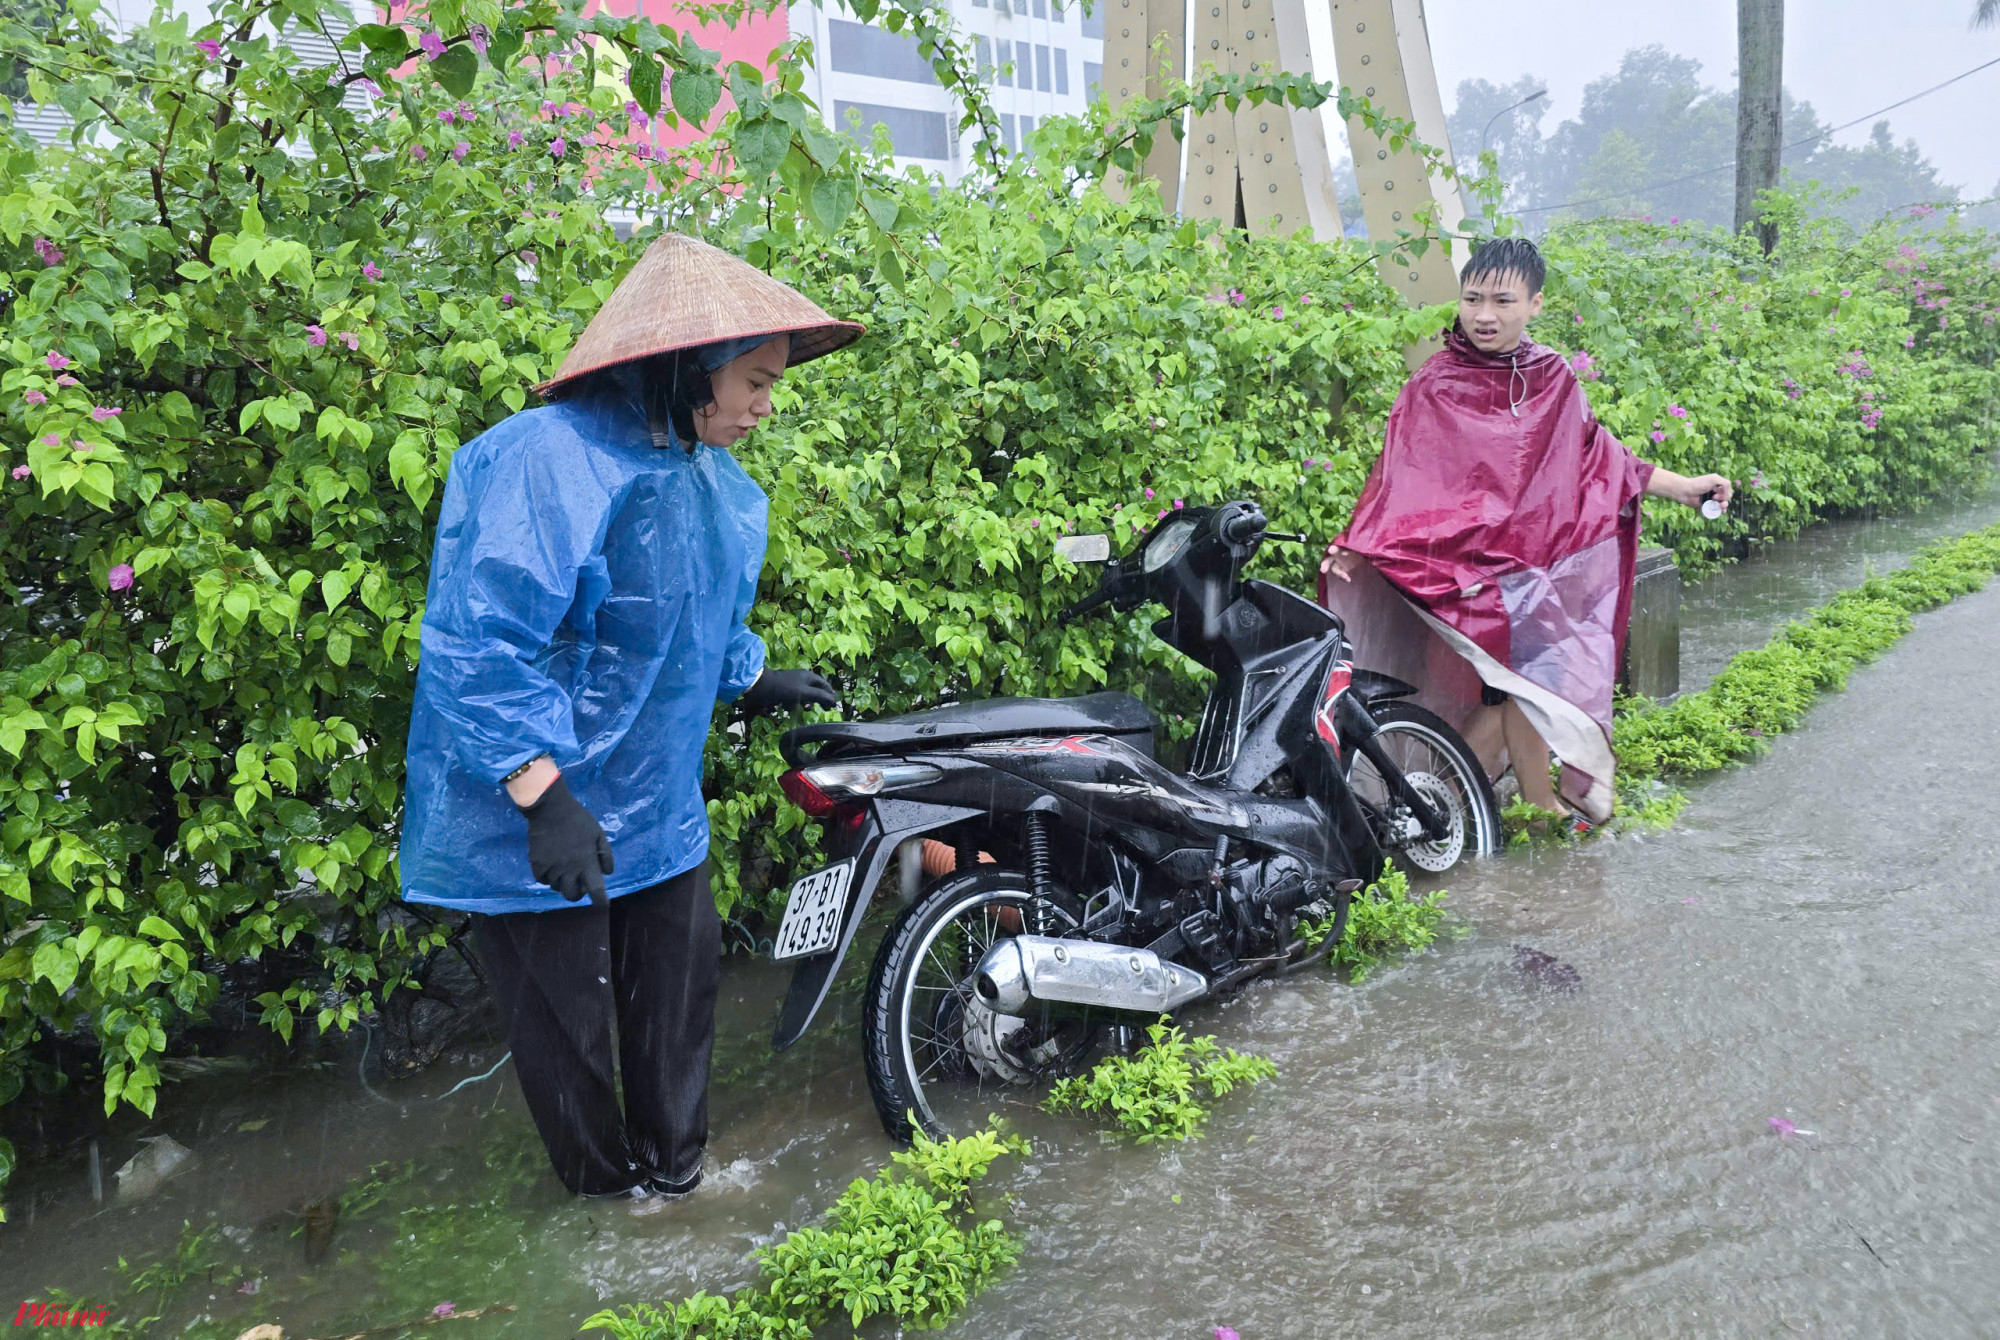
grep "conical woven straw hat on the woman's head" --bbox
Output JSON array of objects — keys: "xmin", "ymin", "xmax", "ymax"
[{"xmin": 536, "ymin": 232, "xmax": 864, "ymax": 396}]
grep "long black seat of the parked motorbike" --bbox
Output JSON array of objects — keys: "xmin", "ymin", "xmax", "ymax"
[{"xmin": 782, "ymin": 692, "xmax": 1158, "ymax": 768}]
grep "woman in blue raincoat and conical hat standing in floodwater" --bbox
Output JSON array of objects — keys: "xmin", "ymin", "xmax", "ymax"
[{"xmin": 400, "ymin": 234, "xmax": 862, "ymax": 1196}]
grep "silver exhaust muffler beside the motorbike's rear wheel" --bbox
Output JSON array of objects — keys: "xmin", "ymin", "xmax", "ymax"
[{"xmin": 972, "ymin": 936, "xmax": 1208, "ymax": 1014}]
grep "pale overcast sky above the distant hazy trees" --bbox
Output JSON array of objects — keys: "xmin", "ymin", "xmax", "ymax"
[{"xmin": 1424, "ymin": 0, "xmax": 2000, "ymax": 198}]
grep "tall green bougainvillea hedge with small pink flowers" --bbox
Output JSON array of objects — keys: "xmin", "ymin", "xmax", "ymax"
[{"xmin": 0, "ymin": 0, "xmax": 1992, "ymax": 1208}]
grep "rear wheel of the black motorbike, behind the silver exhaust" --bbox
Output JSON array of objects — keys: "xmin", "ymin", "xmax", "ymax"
[{"xmin": 862, "ymin": 866, "xmax": 1104, "ymax": 1140}]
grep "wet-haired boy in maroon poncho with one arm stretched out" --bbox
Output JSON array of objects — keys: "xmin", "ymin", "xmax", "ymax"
[{"xmin": 1320, "ymin": 238, "xmax": 1730, "ymax": 826}]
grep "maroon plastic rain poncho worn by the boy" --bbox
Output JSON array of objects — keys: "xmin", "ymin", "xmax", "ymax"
[{"xmin": 1320, "ymin": 326, "xmax": 1652, "ymax": 820}]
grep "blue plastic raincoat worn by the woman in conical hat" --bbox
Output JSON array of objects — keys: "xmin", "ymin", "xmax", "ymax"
[{"xmin": 400, "ymin": 370, "xmax": 770, "ymax": 912}]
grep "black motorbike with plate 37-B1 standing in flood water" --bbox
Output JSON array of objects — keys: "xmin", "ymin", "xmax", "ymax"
[{"xmin": 774, "ymin": 502, "xmax": 1500, "ymax": 1138}]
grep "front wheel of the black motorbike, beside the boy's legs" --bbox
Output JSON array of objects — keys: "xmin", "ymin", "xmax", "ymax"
[{"xmin": 1348, "ymin": 702, "xmax": 1504, "ymax": 874}]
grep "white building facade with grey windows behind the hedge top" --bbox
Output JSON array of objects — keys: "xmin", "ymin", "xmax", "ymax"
[{"xmin": 788, "ymin": 0, "xmax": 1108, "ymax": 182}]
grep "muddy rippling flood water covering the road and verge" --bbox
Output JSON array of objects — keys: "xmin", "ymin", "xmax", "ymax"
[{"xmin": 0, "ymin": 486, "xmax": 2000, "ymax": 1340}]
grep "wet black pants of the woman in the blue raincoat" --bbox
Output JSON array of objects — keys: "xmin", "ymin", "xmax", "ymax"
[{"xmin": 472, "ymin": 864, "xmax": 722, "ymax": 1196}]
